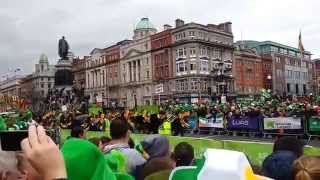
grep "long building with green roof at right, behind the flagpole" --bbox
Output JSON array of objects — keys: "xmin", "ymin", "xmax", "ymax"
[{"xmin": 242, "ymin": 41, "xmax": 313, "ymax": 95}]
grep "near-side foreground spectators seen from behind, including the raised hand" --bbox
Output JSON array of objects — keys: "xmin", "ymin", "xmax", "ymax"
[{"xmin": 2, "ymin": 116, "xmax": 320, "ymax": 180}]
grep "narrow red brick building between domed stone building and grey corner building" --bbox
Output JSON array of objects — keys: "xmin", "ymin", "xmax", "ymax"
[{"xmin": 151, "ymin": 24, "xmax": 173, "ymax": 101}]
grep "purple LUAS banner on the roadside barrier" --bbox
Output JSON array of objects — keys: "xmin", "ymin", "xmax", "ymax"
[{"xmin": 228, "ymin": 116, "xmax": 259, "ymax": 130}]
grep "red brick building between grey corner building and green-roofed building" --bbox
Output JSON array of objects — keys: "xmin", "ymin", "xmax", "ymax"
[{"xmin": 233, "ymin": 46, "xmax": 265, "ymax": 95}]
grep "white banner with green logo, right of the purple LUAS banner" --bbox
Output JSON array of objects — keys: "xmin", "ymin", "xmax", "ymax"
[{"xmin": 263, "ymin": 117, "xmax": 302, "ymax": 130}]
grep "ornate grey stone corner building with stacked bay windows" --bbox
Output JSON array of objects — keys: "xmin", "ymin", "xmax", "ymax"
[{"xmin": 171, "ymin": 19, "xmax": 233, "ymax": 103}]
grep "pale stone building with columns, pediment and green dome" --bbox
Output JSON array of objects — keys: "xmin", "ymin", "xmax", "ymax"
[{"xmin": 120, "ymin": 18, "xmax": 157, "ymax": 108}]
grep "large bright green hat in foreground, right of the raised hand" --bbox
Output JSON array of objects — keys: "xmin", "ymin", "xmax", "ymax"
[{"xmin": 61, "ymin": 139, "xmax": 116, "ymax": 180}]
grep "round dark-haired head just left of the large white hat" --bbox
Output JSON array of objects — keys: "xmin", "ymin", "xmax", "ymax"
[{"xmin": 173, "ymin": 142, "xmax": 194, "ymax": 166}]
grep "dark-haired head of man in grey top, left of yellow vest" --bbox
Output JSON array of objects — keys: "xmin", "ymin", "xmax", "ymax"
[{"xmin": 110, "ymin": 119, "xmax": 130, "ymax": 142}]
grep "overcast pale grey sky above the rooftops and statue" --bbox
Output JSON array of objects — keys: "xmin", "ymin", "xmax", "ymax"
[{"xmin": 0, "ymin": 0, "xmax": 320, "ymax": 75}]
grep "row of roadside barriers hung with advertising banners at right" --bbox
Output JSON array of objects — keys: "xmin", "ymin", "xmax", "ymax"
[{"xmin": 187, "ymin": 116, "xmax": 320, "ymax": 141}]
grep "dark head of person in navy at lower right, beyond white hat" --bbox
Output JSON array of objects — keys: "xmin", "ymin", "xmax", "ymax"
[{"xmin": 273, "ymin": 136, "xmax": 304, "ymax": 157}]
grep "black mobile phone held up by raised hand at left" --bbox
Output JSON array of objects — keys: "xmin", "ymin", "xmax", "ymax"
[{"xmin": 0, "ymin": 130, "xmax": 55, "ymax": 151}]
